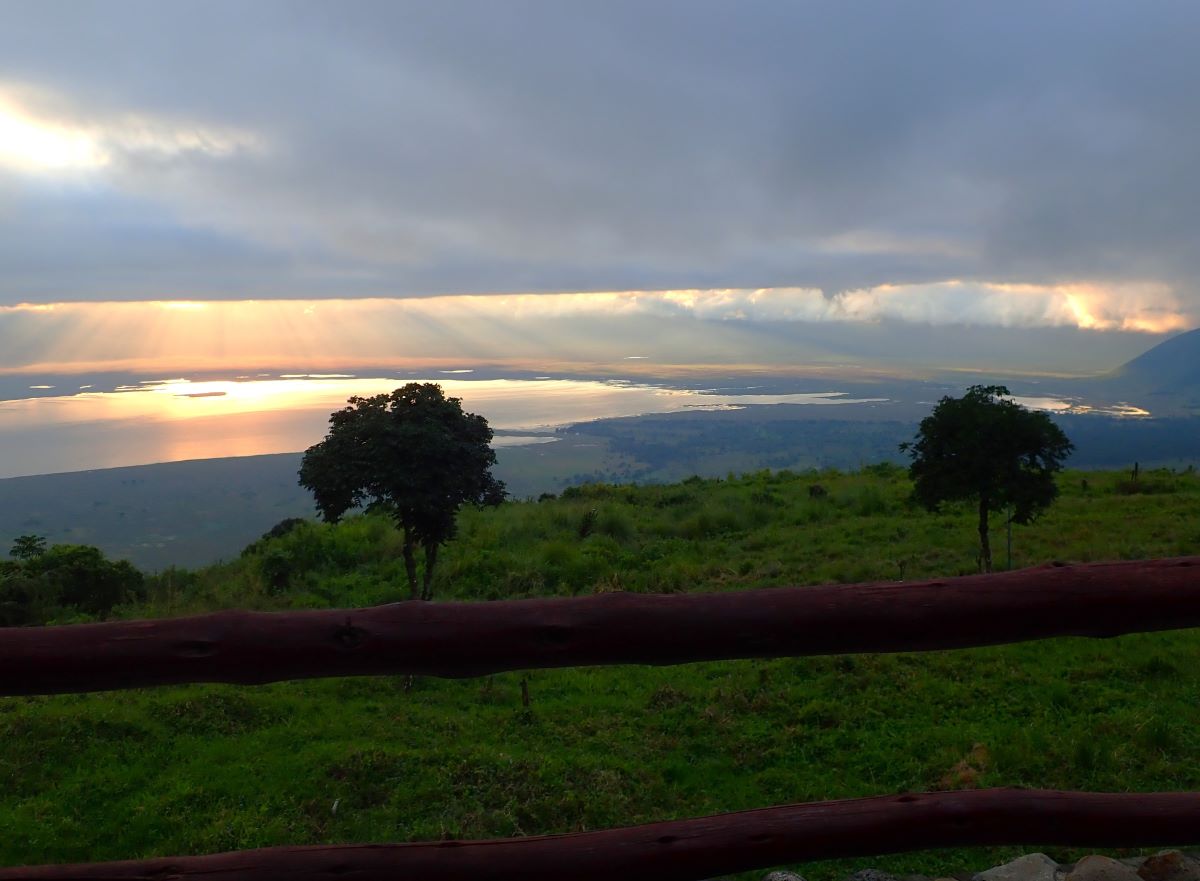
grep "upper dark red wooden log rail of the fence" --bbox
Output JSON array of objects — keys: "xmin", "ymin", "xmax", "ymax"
[{"xmin": 7, "ymin": 557, "xmax": 1200, "ymax": 695}]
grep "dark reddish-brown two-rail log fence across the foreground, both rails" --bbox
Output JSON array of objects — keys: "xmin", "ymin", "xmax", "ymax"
[{"xmin": 7, "ymin": 557, "xmax": 1200, "ymax": 881}]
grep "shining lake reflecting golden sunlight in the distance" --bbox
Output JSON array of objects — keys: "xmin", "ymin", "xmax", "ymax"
[{"xmin": 0, "ymin": 370, "xmax": 880, "ymax": 478}]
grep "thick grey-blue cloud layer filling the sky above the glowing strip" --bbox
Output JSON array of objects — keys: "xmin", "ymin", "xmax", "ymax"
[{"xmin": 0, "ymin": 0, "xmax": 1200, "ymax": 316}]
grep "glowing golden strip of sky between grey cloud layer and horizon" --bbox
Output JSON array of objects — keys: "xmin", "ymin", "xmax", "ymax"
[{"xmin": 0, "ymin": 290, "xmax": 1182, "ymax": 376}]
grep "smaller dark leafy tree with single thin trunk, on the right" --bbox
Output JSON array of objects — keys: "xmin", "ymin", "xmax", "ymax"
[{"xmin": 900, "ymin": 385, "xmax": 1074, "ymax": 573}]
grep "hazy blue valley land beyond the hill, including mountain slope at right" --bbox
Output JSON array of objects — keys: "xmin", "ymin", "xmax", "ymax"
[{"xmin": 0, "ymin": 331, "xmax": 1200, "ymax": 570}]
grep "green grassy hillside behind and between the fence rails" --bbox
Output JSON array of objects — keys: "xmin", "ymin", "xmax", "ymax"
[{"xmin": 0, "ymin": 466, "xmax": 1200, "ymax": 881}]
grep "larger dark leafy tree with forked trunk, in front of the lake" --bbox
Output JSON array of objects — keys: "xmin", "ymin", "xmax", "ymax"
[{"xmin": 300, "ymin": 383, "xmax": 504, "ymax": 600}]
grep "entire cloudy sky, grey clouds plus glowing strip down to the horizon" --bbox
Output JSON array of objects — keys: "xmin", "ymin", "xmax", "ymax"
[{"xmin": 0, "ymin": 0, "xmax": 1200, "ymax": 372}]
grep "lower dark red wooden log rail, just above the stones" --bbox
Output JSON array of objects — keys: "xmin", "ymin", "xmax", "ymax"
[{"xmin": 0, "ymin": 790, "xmax": 1200, "ymax": 881}]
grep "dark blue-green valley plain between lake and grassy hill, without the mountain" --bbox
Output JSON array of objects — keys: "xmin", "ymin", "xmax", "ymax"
[{"xmin": 0, "ymin": 404, "xmax": 1200, "ymax": 570}]
